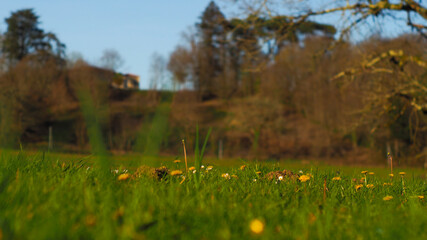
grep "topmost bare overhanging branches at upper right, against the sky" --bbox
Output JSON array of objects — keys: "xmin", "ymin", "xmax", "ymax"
[{"xmin": 232, "ymin": 0, "xmax": 427, "ymax": 40}]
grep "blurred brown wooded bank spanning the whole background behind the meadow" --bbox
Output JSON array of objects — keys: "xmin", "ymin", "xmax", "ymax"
[{"xmin": 0, "ymin": 2, "xmax": 427, "ymax": 165}]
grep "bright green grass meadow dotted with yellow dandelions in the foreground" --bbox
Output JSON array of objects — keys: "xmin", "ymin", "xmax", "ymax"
[{"xmin": 0, "ymin": 151, "xmax": 427, "ymax": 239}]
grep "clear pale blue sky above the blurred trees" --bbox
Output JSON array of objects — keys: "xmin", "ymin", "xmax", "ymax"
[{"xmin": 0, "ymin": 0, "xmax": 422, "ymax": 88}]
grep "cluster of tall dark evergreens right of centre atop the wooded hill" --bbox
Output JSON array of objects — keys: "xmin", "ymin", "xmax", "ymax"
[{"xmin": 168, "ymin": 2, "xmax": 336, "ymax": 100}]
